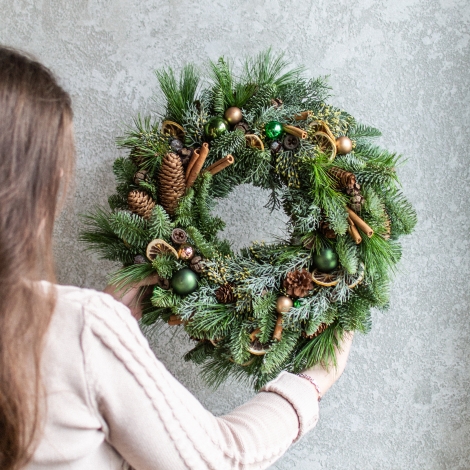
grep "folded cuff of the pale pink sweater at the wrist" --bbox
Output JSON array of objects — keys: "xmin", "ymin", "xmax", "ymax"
[{"xmin": 261, "ymin": 372, "xmax": 319, "ymax": 442}]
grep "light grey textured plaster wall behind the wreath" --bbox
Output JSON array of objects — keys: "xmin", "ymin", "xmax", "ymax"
[{"xmin": 0, "ymin": 0, "xmax": 470, "ymax": 470}]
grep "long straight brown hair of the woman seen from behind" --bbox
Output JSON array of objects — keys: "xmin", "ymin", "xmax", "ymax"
[{"xmin": 0, "ymin": 45, "xmax": 74, "ymax": 470}]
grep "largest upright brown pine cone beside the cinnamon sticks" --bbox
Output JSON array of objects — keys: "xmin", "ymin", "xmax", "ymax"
[{"xmin": 158, "ymin": 153, "xmax": 186, "ymax": 215}]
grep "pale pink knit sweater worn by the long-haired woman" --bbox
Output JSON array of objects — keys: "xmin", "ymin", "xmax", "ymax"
[{"xmin": 28, "ymin": 286, "xmax": 318, "ymax": 470}]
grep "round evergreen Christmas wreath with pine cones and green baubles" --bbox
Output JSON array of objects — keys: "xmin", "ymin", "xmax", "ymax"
[{"xmin": 81, "ymin": 50, "xmax": 416, "ymax": 388}]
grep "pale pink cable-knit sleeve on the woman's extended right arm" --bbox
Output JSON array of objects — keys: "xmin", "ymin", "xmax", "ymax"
[{"xmin": 81, "ymin": 293, "xmax": 318, "ymax": 470}]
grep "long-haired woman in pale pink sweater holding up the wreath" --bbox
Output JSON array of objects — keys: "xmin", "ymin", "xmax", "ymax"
[{"xmin": 0, "ymin": 47, "xmax": 352, "ymax": 470}]
